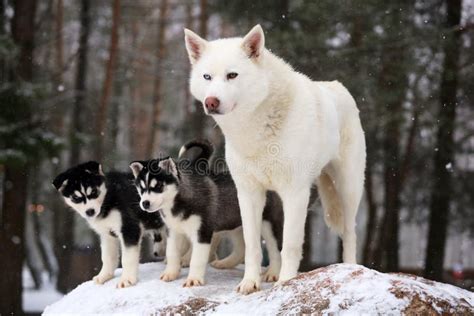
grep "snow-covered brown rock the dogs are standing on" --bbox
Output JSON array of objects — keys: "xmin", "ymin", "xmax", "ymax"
[{"xmin": 44, "ymin": 263, "xmax": 474, "ymax": 315}]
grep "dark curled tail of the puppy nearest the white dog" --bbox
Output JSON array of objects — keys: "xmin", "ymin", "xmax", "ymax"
[{"xmin": 178, "ymin": 139, "xmax": 214, "ymax": 170}]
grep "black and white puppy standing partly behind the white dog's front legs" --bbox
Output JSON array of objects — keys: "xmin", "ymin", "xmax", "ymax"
[{"xmin": 130, "ymin": 141, "xmax": 283, "ymax": 286}]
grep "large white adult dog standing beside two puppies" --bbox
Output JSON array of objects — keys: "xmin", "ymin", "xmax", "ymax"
[{"xmin": 185, "ymin": 25, "xmax": 366, "ymax": 294}]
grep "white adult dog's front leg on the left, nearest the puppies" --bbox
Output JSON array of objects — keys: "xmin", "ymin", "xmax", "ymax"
[{"xmin": 237, "ymin": 185, "xmax": 266, "ymax": 294}]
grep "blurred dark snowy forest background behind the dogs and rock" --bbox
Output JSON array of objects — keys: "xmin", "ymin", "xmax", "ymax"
[{"xmin": 0, "ymin": 0, "xmax": 474, "ymax": 314}]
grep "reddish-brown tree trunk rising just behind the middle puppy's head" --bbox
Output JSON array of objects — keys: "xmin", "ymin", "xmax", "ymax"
[{"xmin": 147, "ymin": 0, "xmax": 168, "ymax": 157}]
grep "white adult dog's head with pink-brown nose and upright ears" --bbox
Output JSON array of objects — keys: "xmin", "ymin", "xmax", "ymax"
[{"xmin": 184, "ymin": 25, "xmax": 270, "ymax": 119}]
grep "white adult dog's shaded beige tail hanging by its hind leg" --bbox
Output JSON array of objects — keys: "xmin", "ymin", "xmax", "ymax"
[{"xmin": 318, "ymin": 172, "xmax": 344, "ymax": 237}]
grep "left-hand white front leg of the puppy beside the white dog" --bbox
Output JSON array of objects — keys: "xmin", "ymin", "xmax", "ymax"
[{"xmin": 160, "ymin": 229, "xmax": 181, "ymax": 282}]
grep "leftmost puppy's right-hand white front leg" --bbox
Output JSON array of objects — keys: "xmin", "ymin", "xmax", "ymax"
[{"xmin": 117, "ymin": 234, "xmax": 141, "ymax": 288}]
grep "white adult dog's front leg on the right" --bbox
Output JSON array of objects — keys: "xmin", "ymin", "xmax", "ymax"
[{"xmin": 278, "ymin": 187, "xmax": 310, "ymax": 284}]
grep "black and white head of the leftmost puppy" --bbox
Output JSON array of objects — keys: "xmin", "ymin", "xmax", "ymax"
[{"xmin": 53, "ymin": 161, "xmax": 107, "ymax": 219}]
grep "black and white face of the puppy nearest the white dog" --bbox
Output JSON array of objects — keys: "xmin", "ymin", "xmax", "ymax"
[{"xmin": 130, "ymin": 158, "xmax": 179, "ymax": 213}]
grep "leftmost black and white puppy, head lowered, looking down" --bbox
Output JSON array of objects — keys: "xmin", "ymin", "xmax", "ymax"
[{"xmin": 53, "ymin": 161, "xmax": 164, "ymax": 288}]
